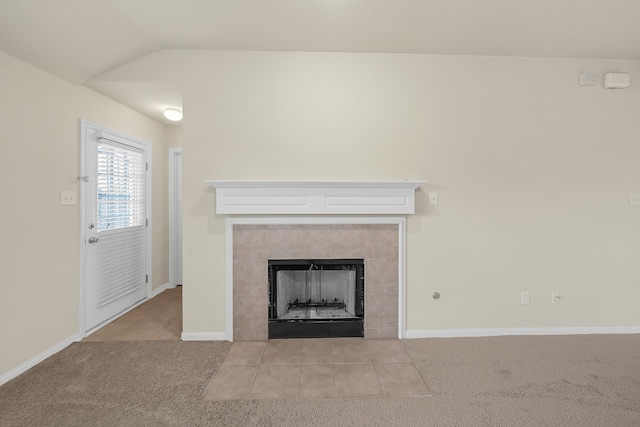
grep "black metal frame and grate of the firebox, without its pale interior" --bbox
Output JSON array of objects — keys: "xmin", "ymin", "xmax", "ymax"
[{"xmin": 268, "ymin": 258, "xmax": 365, "ymax": 339}]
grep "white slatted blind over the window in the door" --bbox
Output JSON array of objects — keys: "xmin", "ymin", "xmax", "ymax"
[{"xmin": 97, "ymin": 144, "xmax": 146, "ymax": 231}]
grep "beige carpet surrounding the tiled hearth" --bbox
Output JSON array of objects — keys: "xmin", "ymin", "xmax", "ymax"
[{"xmin": 0, "ymin": 335, "xmax": 640, "ymax": 426}]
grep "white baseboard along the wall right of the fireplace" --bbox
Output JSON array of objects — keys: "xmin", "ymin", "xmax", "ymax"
[{"xmin": 405, "ymin": 326, "xmax": 640, "ymax": 339}]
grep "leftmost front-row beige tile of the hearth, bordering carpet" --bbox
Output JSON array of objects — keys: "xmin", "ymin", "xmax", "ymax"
[{"xmin": 203, "ymin": 365, "xmax": 258, "ymax": 399}]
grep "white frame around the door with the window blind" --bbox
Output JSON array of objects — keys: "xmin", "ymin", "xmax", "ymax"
[{"xmin": 78, "ymin": 119, "xmax": 153, "ymax": 338}]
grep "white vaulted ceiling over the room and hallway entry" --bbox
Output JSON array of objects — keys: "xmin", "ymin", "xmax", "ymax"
[{"xmin": 0, "ymin": 0, "xmax": 640, "ymax": 124}]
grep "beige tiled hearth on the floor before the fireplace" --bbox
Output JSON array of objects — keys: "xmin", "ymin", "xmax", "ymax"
[{"xmin": 204, "ymin": 338, "xmax": 431, "ymax": 400}]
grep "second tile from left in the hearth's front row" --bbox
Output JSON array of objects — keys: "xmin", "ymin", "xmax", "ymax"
[{"xmin": 251, "ymin": 365, "xmax": 300, "ymax": 399}]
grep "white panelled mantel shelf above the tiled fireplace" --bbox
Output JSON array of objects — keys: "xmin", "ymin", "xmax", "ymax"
[{"xmin": 206, "ymin": 180, "xmax": 424, "ymax": 215}]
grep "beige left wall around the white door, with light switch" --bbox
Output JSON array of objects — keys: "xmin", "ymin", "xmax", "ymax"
[{"xmin": 0, "ymin": 52, "xmax": 167, "ymax": 375}]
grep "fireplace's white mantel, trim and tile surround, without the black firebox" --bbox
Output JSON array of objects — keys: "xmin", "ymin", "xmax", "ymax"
[{"xmin": 206, "ymin": 180, "xmax": 424, "ymax": 341}]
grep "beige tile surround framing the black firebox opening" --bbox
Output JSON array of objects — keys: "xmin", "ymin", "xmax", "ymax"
[{"xmin": 233, "ymin": 224, "xmax": 399, "ymax": 341}]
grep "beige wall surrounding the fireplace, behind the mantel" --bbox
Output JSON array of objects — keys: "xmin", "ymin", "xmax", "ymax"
[{"xmin": 121, "ymin": 51, "xmax": 640, "ymax": 338}]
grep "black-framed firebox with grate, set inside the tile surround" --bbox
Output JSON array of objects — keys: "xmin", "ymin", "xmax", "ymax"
[{"xmin": 268, "ymin": 259, "xmax": 365, "ymax": 339}]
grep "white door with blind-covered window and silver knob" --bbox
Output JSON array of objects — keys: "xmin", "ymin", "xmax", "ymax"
[{"xmin": 84, "ymin": 123, "xmax": 148, "ymax": 331}]
